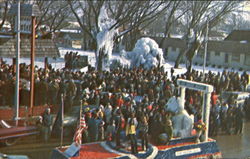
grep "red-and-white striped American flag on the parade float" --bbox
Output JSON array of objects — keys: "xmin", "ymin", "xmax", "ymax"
[{"xmin": 73, "ymin": 115, "xmax": 88, "ymax": 145}]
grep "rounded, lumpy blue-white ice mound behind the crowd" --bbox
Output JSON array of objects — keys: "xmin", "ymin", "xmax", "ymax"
[{"xmin": 127, "ymin": 38, "xmax": 163, "ymax": 69}]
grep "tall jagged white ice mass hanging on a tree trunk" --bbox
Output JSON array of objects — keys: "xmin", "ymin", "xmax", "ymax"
[{"xmin": 95, "ymin": 6, "xmax": 117, "ymax": 70}]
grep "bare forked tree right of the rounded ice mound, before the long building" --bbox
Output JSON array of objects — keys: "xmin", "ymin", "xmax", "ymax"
[{"xmin": 175, "ymin": 0, "xmax": 241, "ymax": 71}]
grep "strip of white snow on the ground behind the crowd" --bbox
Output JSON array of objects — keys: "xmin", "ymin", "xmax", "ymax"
[{"xmin": 3, "ymin": 48, "xmax": 250, "ymax": 75}]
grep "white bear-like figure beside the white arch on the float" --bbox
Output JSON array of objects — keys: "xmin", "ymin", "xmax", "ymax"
[{"xmin": 165, "ymin": 96, "xmax": 194, "ymax": 138}]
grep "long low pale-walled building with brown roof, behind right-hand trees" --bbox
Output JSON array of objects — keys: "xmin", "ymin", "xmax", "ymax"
[{"xmin": 153, "ymin": 32, "xmax": 250, "ymax": 70}]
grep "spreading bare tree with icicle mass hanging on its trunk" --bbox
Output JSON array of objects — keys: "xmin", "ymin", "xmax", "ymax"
[{"xmin": 68, "ymin": 0, "xmax": 168, "ymax": 70}]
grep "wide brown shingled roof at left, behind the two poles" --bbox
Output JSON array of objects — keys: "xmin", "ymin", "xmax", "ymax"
[{"xmin": 0, "ymin": 39, "xmax": 59, "ymax": 57}]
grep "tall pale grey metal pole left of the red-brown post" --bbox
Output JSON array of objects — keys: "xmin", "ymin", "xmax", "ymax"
[{"xmin": 14, "ymin": 0, "xmax": 20, "ymax": 126}]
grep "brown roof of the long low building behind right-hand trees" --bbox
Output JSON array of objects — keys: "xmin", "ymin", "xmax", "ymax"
[{"xmin": 153, "ymin": 37, "xmax": 250, "ymax": 54}]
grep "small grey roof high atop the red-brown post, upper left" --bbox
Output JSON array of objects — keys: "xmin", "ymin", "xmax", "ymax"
[{"xmin": 8, "ymin": 4, "xmax": 41, "ymax": 16}]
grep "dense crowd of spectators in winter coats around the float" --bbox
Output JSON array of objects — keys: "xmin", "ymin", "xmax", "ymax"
[{"xmin": 0, "ymin": 60, "xmax": 250, "ymax": 148}]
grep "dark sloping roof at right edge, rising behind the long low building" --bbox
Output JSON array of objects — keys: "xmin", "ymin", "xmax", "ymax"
[{"xmin": 225, "ymin": 30, "xmax": 250, "ymax": 42}]
